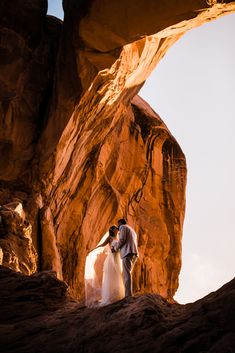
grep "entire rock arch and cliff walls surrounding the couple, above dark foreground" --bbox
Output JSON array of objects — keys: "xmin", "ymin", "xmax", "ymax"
[{"xmin": 0, "ymin": 0, "xmax": 235, "ymax": 300}]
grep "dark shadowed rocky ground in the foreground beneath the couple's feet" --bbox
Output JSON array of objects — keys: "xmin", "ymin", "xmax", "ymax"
[{"xmin": 0, "ymin": 267, "xmax": 235, "ymax": 353}]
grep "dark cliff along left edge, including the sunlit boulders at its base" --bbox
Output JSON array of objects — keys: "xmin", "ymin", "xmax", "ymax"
[{"xmin": 0, "ymin": 0, "xmax": 62, "ymax": 273}]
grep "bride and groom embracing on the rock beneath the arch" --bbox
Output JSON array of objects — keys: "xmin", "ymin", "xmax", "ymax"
[{"xmin": 85, "ymin": 219, "xmax": 138, "ymax": 306}]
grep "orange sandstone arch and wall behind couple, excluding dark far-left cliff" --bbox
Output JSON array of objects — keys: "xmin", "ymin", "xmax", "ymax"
[{"xmin": 36, "ymin": 0, "xmax": 235, "ymax": 298}]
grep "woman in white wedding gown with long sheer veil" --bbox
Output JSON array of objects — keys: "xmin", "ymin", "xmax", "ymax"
[{"xmin": 85, "ymin": 226, "xmax": 125, "ymax": 307}]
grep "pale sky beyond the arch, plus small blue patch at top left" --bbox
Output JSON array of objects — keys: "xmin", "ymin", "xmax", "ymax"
[{"xmin": 48, "ymin": 0, "xmax": 235, "ymax": 304}]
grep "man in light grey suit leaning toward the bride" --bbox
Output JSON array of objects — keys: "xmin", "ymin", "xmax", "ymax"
[{"xmin": 112, "ymin": 218, "xmax": 138, "ymax": 297}]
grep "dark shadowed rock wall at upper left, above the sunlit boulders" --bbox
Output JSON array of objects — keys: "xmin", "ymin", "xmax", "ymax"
[{"xmin": 0, "ymin": 0, "xmax": 61, "ymax": 181}]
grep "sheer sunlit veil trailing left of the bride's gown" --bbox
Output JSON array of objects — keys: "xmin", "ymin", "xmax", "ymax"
[{"xmin": 85, "ymin": 232, "xmax": 109, "ymax": 307}]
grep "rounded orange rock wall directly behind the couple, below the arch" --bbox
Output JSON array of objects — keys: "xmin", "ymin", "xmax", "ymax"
[{"xmin": 45, "ymin": 97, "xmax": 186, "ymax": 298}]
